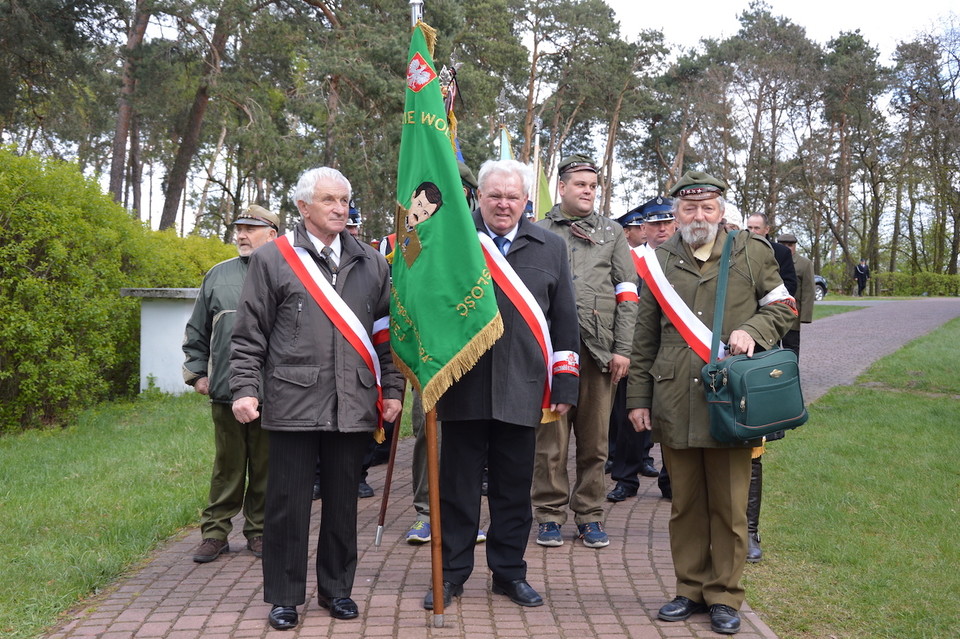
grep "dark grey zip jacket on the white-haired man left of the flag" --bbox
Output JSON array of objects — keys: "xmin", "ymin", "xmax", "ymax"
[{"xmin": 230, "ymin": 222, "xmax": 403, "ymax": 432}]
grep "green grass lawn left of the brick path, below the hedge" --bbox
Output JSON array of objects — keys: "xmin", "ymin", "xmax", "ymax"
[{"xmin": 0, "ymin": 395, "xmax": 213, "ymax": 639}]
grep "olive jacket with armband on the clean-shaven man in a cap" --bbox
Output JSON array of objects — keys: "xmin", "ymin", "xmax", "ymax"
[{"xmin": 537, "ymin": 209, "xmax": 637, "ymax": 371}]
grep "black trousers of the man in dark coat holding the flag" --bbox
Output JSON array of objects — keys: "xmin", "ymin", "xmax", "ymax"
[{"xmin": 440, "ymin": 420, "xmax": 536, "ymax": 584}]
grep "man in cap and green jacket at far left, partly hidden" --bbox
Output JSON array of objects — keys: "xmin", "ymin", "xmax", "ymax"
[{"xmin": 183, "ymin": 204, "xmax": 280, "ymax": 563}]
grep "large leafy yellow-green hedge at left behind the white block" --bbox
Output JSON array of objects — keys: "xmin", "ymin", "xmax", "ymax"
[{"xmin": 0, "ymin": 149, "xmax": 236, "ymax": 433}]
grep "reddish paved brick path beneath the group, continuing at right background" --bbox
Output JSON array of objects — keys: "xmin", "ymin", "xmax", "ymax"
[{"xmin": 47, "ymin": 299, "xmax": 960, "ymax": 639}]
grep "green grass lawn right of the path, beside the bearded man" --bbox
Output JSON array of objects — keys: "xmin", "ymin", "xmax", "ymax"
[{"xmin": 745, "ymin": 320, "xmax": 960, "ymax": 639}]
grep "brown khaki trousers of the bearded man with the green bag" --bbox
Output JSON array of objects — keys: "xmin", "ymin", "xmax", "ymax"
[{"xmin": 661, "ymin": 446, "xmax": 752, "ymax": 610}]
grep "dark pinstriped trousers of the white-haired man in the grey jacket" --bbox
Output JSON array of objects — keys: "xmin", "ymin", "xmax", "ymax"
[{"xmin": 263, "ymin": 431, "xmax": 370, "ymax": 606}]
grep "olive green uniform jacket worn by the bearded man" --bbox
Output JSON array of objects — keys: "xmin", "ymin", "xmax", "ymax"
[{"xmin": 627, "ymin": 230, "xmax": 794, "ymax": 449}]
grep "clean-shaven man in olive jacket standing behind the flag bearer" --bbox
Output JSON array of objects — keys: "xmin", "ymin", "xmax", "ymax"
[{"xmin": 533, "ymin": 155, "xmax": 637, "ymax": 548}]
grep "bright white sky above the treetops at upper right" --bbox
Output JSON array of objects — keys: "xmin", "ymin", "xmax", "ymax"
[{"xmin": 607, "ymin": 0, "xmax": 960, "ymax": 64}]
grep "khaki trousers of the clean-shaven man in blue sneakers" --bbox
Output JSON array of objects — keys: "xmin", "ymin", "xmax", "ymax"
[{"xmin": 532, "ymin": 350, "xmax": 616, "ymax": 525}]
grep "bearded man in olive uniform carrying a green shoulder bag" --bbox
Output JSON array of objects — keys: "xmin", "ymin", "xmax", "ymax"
[{"xmin": 627, "ymin": 172, "xmax": 796, "ymax": 634}]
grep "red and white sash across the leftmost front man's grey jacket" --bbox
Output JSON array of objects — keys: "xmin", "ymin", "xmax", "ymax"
[{"xmin": 274, "ymin": 235, "xmax": 390, "ymax": 435}]
